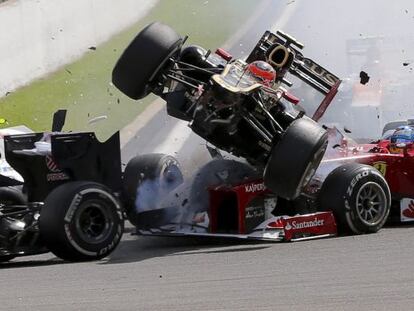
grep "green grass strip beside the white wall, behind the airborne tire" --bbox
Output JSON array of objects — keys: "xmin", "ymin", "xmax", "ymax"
[{"xmin": 0, "ymin": 0, "xmax": 257, "ymax": 139}]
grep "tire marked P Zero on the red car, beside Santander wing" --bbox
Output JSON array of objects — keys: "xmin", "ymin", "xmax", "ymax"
[{"xmin": 319, "ymin": 163, "xmax": 391, "ymax": 234}]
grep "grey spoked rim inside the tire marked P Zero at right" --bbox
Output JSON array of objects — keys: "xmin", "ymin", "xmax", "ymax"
[{"xmin": 356, "ymin": 182, "xmax": 387, "ymax": 226}]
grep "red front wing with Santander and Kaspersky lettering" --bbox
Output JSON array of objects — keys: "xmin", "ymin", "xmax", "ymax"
[{"xmin": 208, "ymin": 180, "xmax": 337, "ymax": 241}]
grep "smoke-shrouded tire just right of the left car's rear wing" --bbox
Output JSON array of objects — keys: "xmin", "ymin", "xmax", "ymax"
[{"xmin": 123, "ymin": 153, "xmax": 184, "ymax": 226}]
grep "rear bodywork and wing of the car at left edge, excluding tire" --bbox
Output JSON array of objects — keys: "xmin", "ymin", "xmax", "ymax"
[{"xmin": 0, "ymin": 113, "xmax": 122, "ymax": 261}]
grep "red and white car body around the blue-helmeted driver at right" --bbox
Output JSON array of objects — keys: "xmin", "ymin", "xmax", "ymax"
[{"xmin": 308, "ymin": 120, "xmax": 414, "ymax": 228}]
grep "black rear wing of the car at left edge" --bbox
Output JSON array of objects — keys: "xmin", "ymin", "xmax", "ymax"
[{"xmin": 3, "ymin": 132, "xmax": 122, "ymax": 202}]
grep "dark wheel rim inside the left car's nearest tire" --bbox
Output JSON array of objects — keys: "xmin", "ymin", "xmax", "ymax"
[{"xmin": 76, "ymin": 200, "xmax": 114, "ymax": 244}]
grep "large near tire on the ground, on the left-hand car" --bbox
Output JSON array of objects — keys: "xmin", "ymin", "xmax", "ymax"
[{"xmin": 39, "ymin": 181, "xmax": 124, "ymax": 261}]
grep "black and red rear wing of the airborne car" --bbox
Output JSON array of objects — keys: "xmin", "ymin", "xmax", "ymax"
[{"xmin": 246, "ymin": 31, "xmax": 342, "ymax": 121}]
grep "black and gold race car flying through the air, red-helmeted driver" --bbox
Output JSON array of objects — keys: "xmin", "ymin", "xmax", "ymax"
[{"xmin": 112, "ymin": 23, "xmax": 340, "ymax": 199}]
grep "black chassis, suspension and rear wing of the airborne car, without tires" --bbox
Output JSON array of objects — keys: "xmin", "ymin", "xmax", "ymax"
[{"xmin": 160, "ymin": 31, "xmax": 340, "ymax": 167}]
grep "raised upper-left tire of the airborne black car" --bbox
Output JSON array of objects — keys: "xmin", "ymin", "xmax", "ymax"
[{"xmin": 112, "ymin": 22, "xmax": 182, "ymax": 100}]
